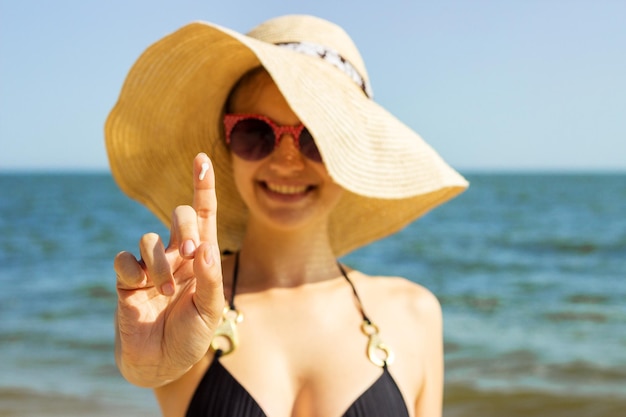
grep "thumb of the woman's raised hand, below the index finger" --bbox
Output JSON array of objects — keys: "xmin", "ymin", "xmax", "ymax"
[{"xmin": 193, "ymin": 243, "xmax": 224, "ymax": 330}]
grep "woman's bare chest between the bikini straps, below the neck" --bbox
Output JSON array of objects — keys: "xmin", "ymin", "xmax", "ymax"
[{"xmin": 207, "ymin": 293, "xmax": 404, "ymax": 417}]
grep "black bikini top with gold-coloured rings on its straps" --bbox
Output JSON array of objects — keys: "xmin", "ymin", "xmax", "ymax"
[{"xmin": 186, "ymin": 254, "xmax": 409, "ymax": 417}]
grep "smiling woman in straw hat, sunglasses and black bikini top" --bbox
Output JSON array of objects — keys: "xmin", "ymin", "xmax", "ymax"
[{"xmin": 106, "ymin": 16, "xmax": 467, "ymax": 417}]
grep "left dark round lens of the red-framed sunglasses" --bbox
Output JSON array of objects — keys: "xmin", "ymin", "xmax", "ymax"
[{"xmin": 225, "ymin": 119, "xmax": 274, "ymax": 161}]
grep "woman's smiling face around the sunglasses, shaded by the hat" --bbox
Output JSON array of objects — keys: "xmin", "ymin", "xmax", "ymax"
[{"xmin": 229, "ymin": 71, "xmax": 343, "ymax": 229}]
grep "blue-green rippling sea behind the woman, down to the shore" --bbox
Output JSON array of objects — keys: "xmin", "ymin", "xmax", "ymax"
[{"xmin": 0, "ymin": 173, "xmax": 626, "ymax": 417}]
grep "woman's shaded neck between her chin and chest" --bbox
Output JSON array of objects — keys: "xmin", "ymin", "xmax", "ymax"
[{"xmin": 239, "ymin": 218, "xmax": 340, "ymax": 288}]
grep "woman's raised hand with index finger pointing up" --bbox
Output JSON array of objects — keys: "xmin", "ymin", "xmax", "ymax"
[{"xmin": 114, "ymin": 154, "xmax": 224, "ymax": 387}]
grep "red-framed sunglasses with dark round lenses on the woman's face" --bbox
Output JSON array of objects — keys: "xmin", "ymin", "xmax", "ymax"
[{"xmin": 224, "ymin": 114, "xmax": 322, "ymax": 162}]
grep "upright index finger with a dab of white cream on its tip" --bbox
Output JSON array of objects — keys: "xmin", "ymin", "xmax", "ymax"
[{"xmin": 193, "ymin": 153, "xmax": 217, "ymax": 245}]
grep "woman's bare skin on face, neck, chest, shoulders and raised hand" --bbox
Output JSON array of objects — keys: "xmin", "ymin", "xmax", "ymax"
[{"xmin": 115, "ymin": 72, "xmax": 443, "ymax": 417}]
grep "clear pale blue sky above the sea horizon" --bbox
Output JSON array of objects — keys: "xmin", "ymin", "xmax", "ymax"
[{"xmin": 0, "ymin": 0, "xmax": 626, "ymax": 171}]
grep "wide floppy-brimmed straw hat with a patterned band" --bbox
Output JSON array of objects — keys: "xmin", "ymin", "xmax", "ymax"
[{"xmin": 105, "ymin": 15, "xmax": 468, "ymax": 256}]
